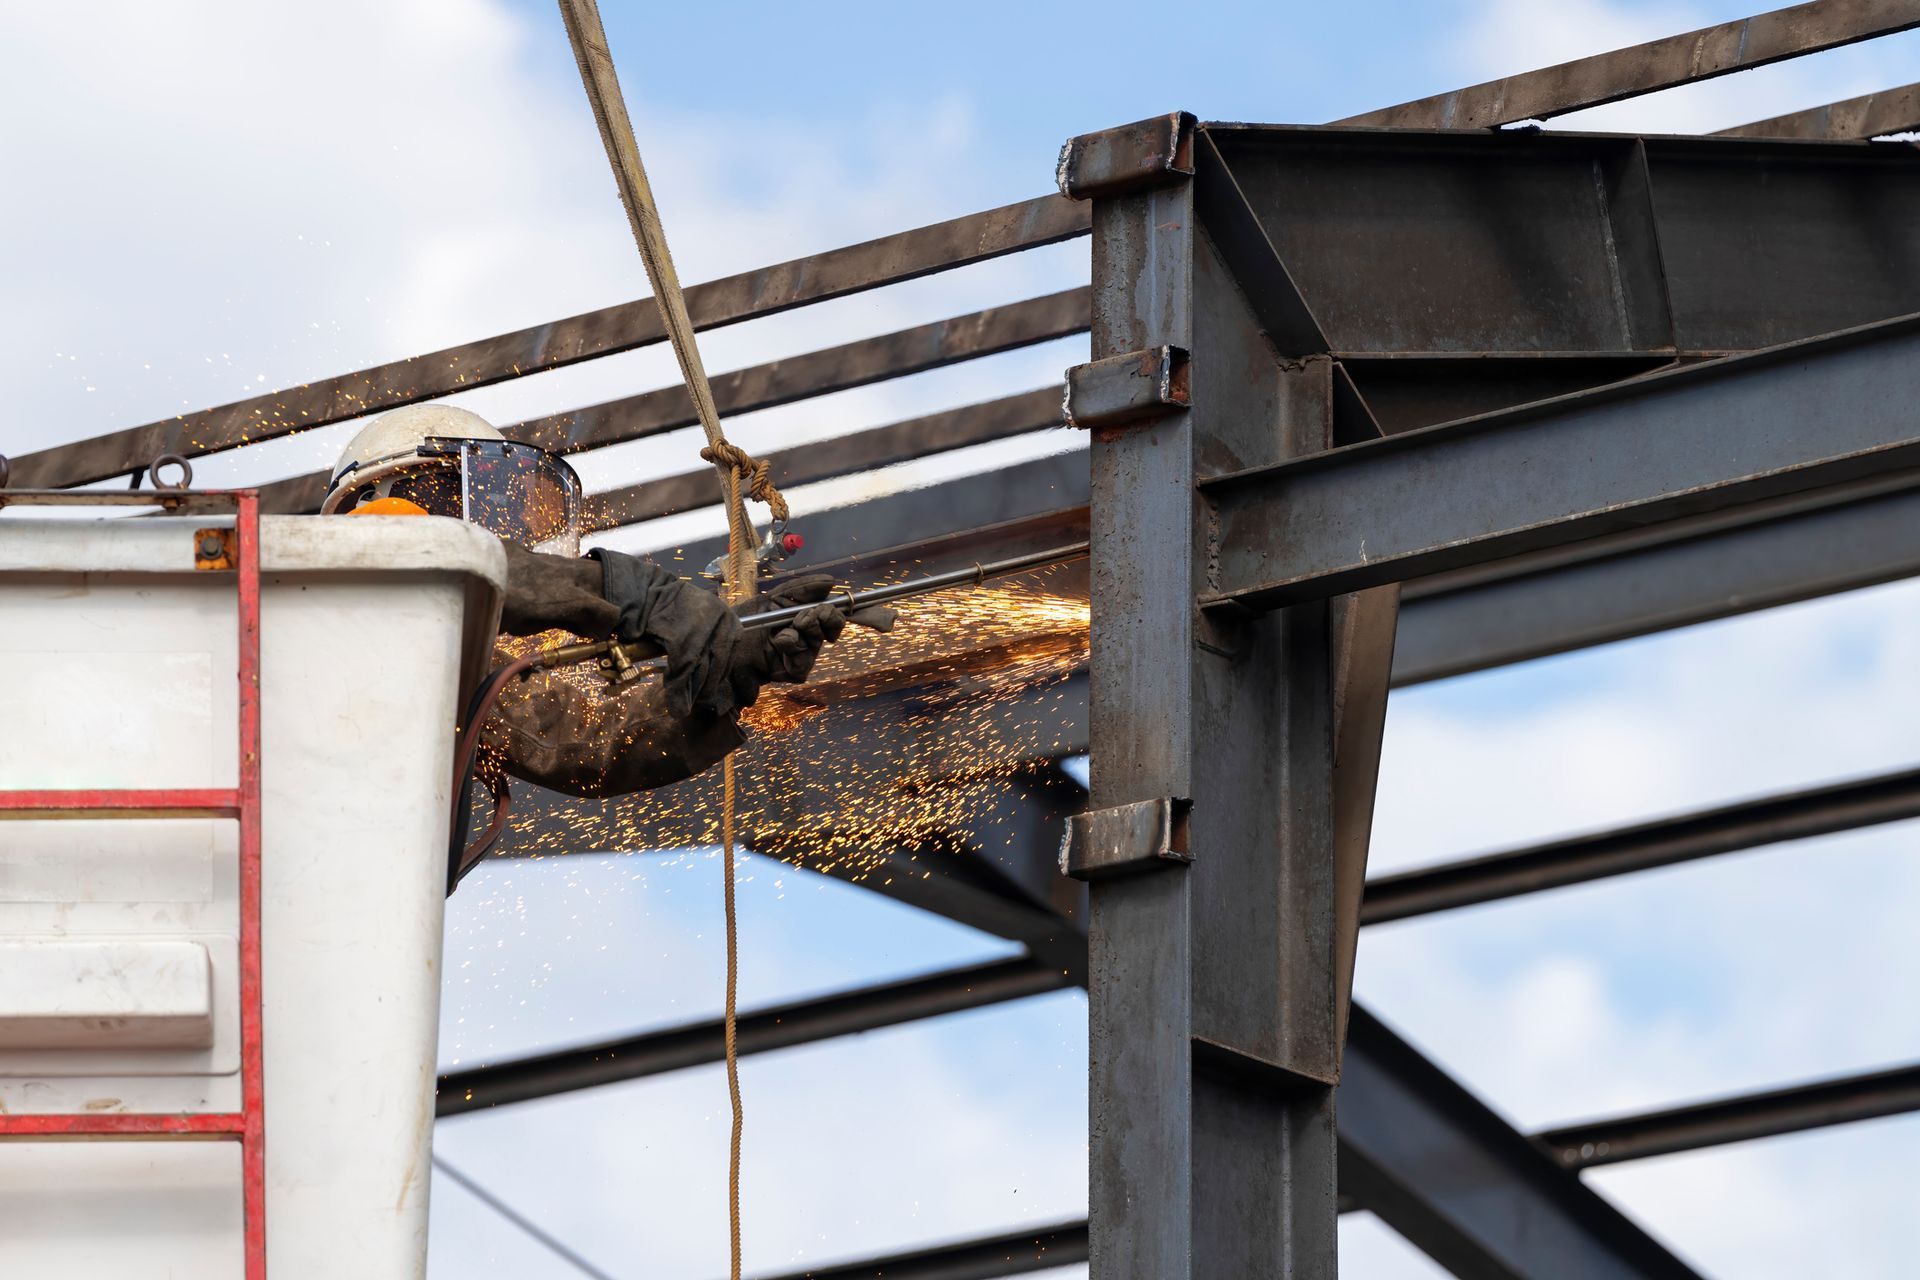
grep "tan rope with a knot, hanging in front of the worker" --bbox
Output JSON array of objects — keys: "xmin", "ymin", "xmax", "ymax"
[{"xmin": 559, "ymin": 0, "xmax": 787, "ymax": 1280}]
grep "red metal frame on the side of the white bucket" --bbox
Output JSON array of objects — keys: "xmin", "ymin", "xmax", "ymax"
[{"xmin": 0, "ymin": 489, "xmax": 267, "ymax": 1280}]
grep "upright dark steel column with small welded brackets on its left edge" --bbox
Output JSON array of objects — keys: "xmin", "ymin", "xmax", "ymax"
[{"xmin": 1060, "ymin": 115, "xmax": 1344, "ymax": 1280}]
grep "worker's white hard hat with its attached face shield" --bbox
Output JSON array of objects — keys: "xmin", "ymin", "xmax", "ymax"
[{"xmin": 321, "ymin": 405, "xmax": 582, "ymax": 555}]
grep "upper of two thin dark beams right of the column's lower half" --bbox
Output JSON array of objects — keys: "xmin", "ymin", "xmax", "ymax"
[{"xmin": 1359, "ymin": 770, "xmax": 1920, "ymax": 925}]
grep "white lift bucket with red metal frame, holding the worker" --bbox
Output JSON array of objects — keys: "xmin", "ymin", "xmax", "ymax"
[{"xmin": 0, "ymin": 491, "xmax": 505, "ymax": 1280}]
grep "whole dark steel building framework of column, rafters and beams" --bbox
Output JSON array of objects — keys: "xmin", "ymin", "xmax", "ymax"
[{"xmin": 13, "ymin": 0, "xmax": 1920, "ymax": 1280}]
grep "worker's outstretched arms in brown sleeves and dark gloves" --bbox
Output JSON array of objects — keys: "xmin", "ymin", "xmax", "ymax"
[{"xmin": 482, "ymin": 543, "xmax": 845, "ymax": 796}]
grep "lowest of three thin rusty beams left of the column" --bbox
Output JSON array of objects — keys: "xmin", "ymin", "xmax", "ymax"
[{"xmin": 588, "ymin": 388, "xmax": 1060, "ymax": 530}]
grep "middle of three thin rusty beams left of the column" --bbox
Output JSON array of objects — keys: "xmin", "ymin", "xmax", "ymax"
[{"xmin": 261, "ymin": 288, "xmax": 1091, "ymax": 514}]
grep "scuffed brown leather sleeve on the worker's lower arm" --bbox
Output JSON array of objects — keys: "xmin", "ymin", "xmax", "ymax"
[{"xmin": 480, "ymin": 649, "xmax": 745, "ymax": 798}]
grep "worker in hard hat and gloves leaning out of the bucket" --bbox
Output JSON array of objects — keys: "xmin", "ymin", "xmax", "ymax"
[{"xmin": 321, "ymin": 405, "xmax": 885, "ymax": 796}]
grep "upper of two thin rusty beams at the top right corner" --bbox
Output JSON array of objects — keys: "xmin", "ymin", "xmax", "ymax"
[{"xmin": 1338, "ymin": 0, "xmax": 1920, "ymax": 129}]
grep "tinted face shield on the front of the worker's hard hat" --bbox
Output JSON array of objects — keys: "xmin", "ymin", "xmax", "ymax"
[{"xmin": 323, "ymin": 436, "xmax": 582, "ymax": 557}]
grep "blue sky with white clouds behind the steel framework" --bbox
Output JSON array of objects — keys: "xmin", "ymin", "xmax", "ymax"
[{"xmin": 0, "ymin": 0, "xmax": 1920, "ymax": 1280}]
